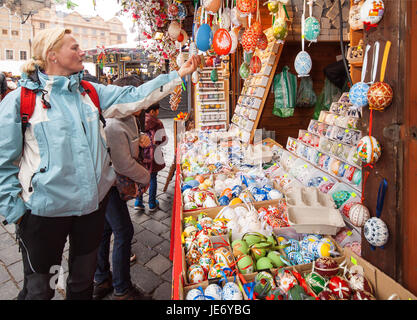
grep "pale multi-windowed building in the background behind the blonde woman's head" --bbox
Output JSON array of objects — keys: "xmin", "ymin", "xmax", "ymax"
[{"xmin": 0, "ymin": 3, "xmax": 127, "ymax": 74}]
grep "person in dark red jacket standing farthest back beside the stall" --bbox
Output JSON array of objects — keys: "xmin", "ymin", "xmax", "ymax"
[{"xmin": 135, "ymin": 103, "xmax": 167, "ymax": 212}]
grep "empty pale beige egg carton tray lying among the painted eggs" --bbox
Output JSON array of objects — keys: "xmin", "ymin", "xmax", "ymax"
[{"xmin": 286, "ymin": 188, "xmax": 345, "ymax": 235}]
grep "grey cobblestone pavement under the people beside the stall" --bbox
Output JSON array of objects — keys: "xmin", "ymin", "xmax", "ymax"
[{"xmin": 0, "ymin": 119, "xmax": 175, "ymax": 300}]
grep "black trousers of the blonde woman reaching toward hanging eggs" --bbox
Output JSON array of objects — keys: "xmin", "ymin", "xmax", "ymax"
[{"xmin": 16, "ymin": 196, "xmax": 108, "ymax": 300}]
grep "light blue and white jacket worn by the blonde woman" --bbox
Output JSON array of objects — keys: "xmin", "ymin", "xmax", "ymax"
[{"xmin": 0, "ymin": 71, "xmax": 181, "ymax": 223}]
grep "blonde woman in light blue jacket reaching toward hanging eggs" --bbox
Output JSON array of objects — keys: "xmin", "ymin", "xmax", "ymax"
[{"xmin": 0, "ymin": 28, "xmax": 199, "ymax": 300}]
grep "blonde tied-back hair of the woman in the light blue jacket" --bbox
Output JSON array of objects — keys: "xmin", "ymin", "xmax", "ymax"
[{"xmin": 22, "ymin": 28, "xmax": 71, "ymax": 75}]
